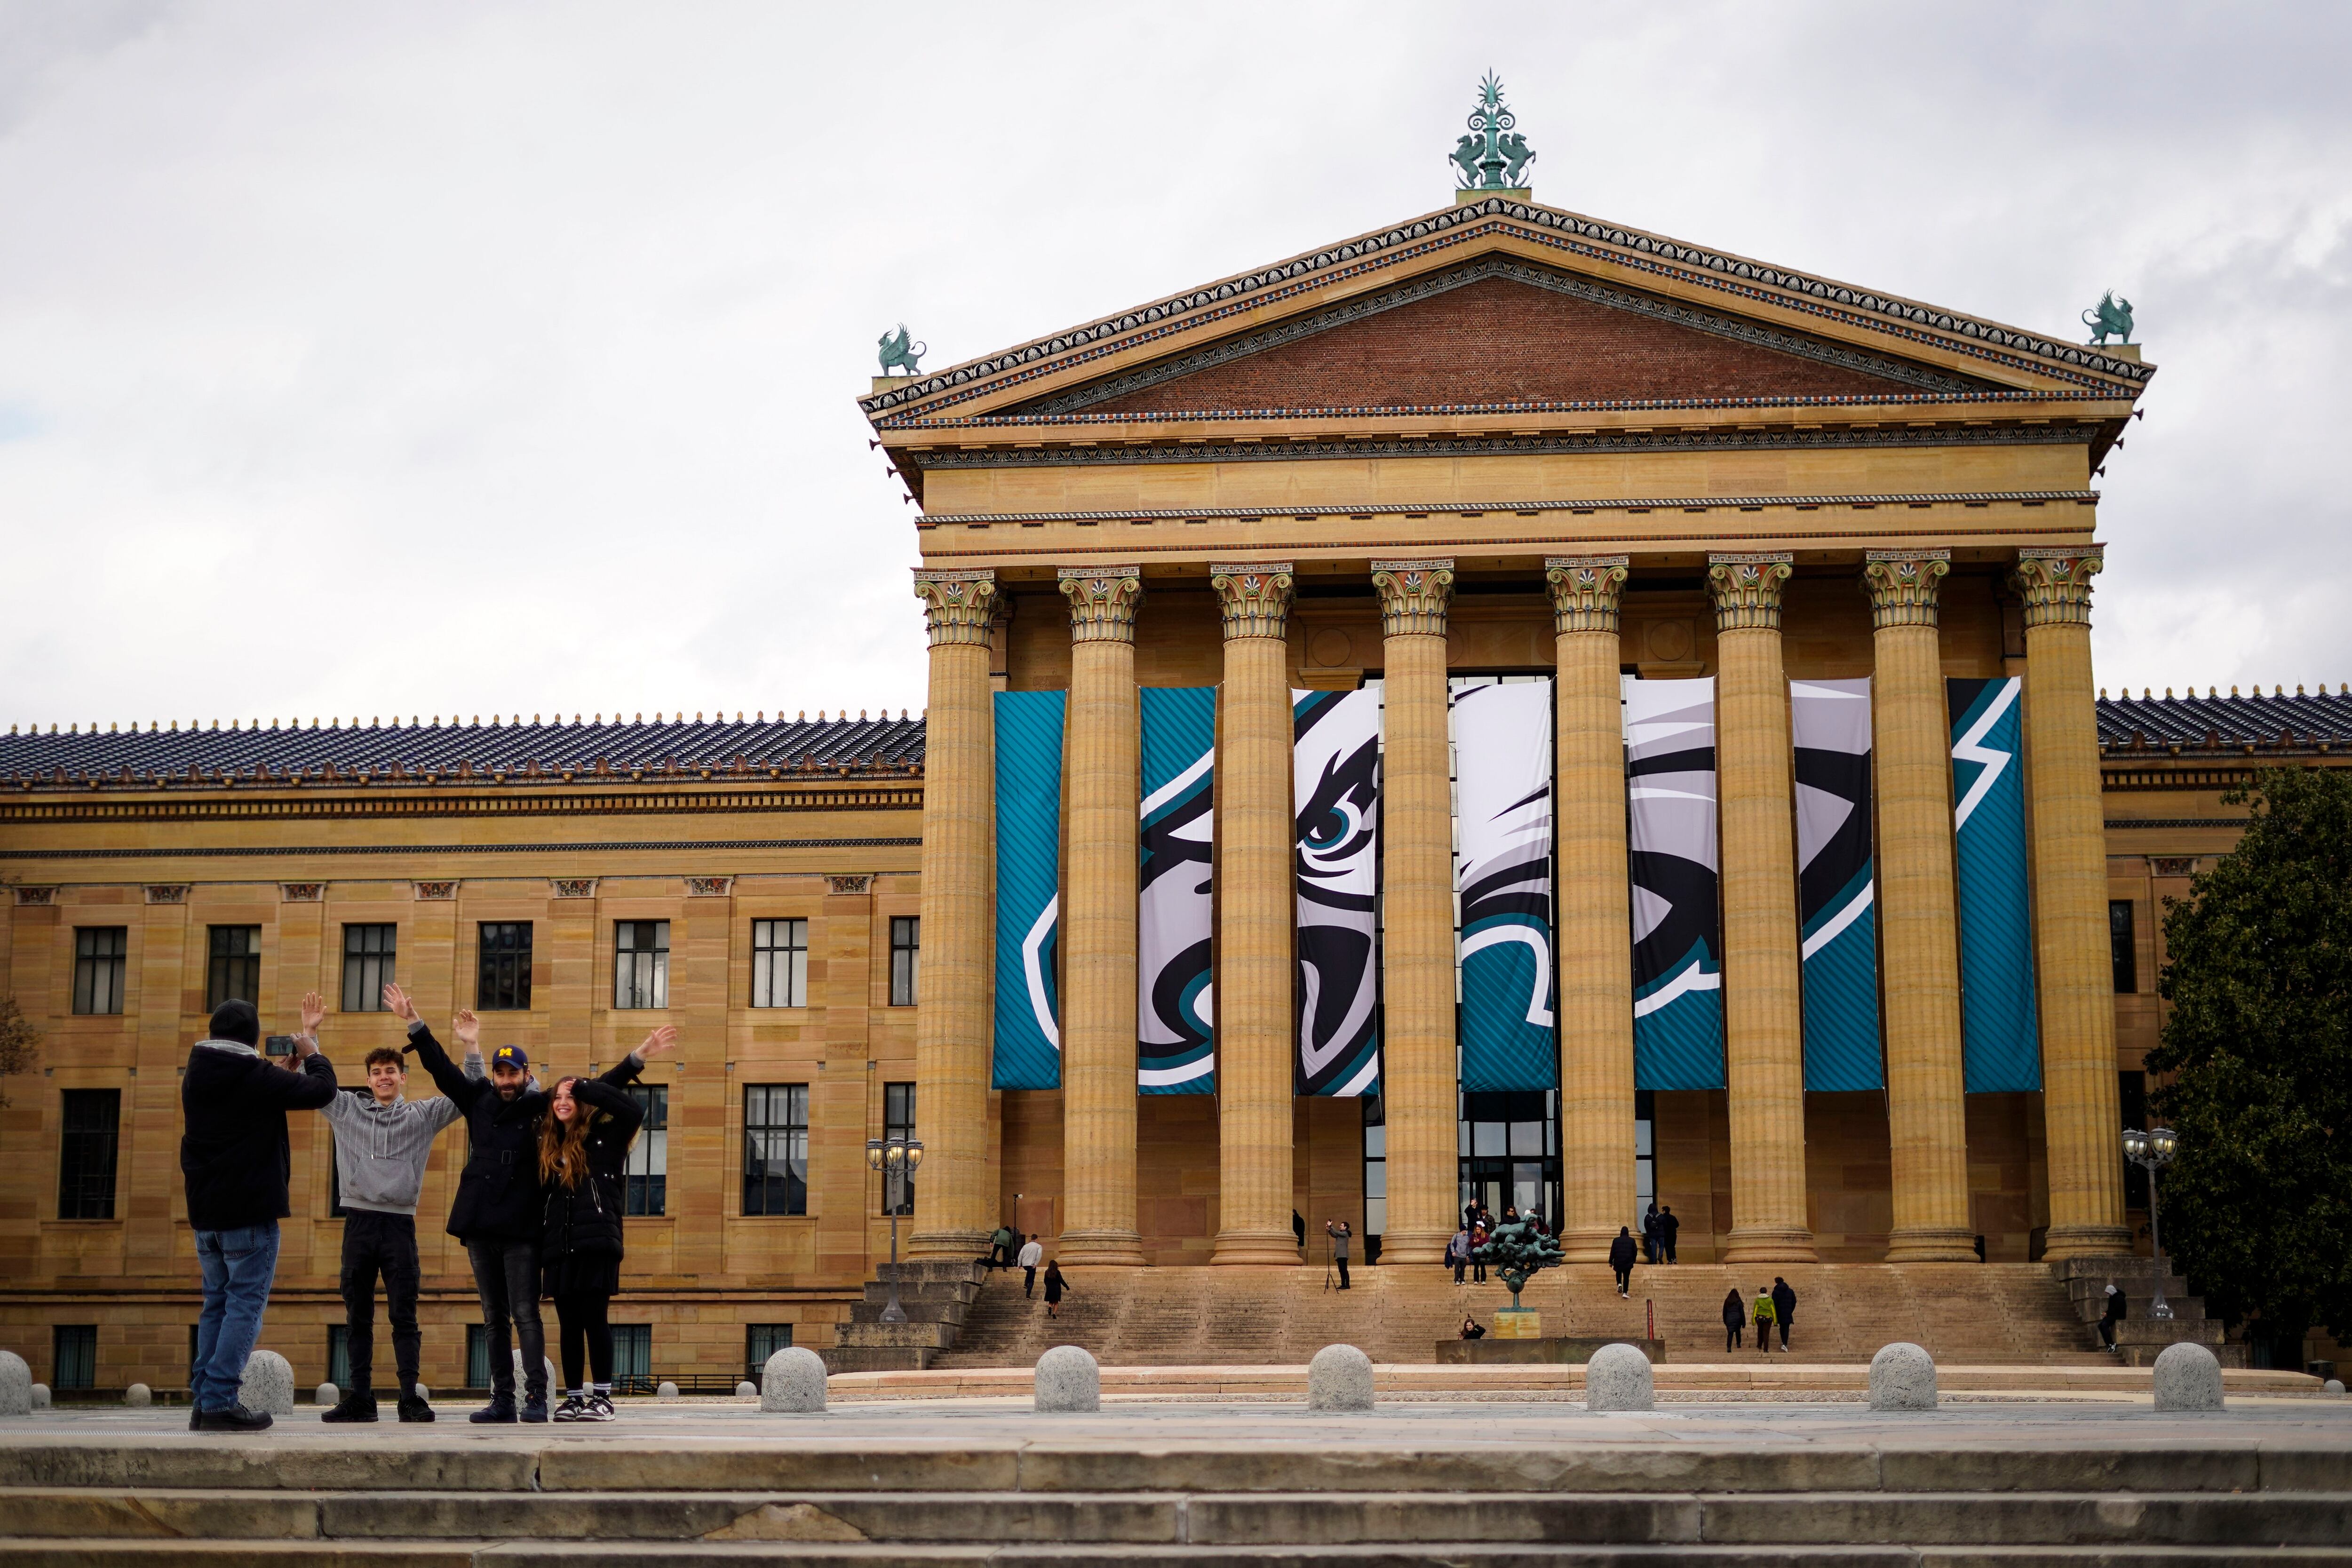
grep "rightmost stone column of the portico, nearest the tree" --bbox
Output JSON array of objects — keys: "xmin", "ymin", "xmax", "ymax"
[{"xmin": 2016, "ymin": 545, "xmax": 2131, "ymax": 1258}]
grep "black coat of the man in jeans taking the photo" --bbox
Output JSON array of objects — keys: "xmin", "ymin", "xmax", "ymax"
[{"xmin": 179, "ymin": 1039, "xmax": 334, "ymax": 1229}]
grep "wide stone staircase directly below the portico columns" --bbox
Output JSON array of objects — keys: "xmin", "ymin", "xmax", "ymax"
[{"xmin": 929, "ymin": 1262, "xmax": 2117, "ymax": 1368}]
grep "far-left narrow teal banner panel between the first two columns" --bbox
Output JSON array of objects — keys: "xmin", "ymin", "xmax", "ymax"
[{"xmin": 988, "ymin": 691, "xmax": 1063, "ymax": 1089}]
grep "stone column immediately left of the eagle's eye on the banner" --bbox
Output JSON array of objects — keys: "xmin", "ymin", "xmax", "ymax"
[{"xmin": 1209, "ymin": 562, "xmax": 1298, "ymax": 1265}]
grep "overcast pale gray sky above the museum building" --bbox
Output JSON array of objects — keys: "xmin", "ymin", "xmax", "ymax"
[{"xmin": 0, "ymin": 0, "xmax": 2352, "ymax": 724}]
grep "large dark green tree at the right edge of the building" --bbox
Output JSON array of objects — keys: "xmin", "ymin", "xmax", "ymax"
[{"xmin": 2147, "ymin": 766, "xmax": 2352, "ymax": 1337}]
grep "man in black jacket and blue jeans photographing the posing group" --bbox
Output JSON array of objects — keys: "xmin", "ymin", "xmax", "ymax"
[{"xmin": 179, "ymin": 1002, "xmax": 334, "ymax": 1432}]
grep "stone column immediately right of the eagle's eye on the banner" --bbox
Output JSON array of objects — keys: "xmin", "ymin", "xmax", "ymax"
[{"xmin": 1371, "ymin": 562, "xmax": 1461, "ymax": 1262}]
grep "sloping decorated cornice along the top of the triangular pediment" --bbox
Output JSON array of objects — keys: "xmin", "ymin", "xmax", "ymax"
[{"xmin": 858, "ymin": 198, "xmax": 2154, "ymax": 418}]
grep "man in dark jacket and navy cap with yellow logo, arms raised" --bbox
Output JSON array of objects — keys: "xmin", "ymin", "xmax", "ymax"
[{"xmin": 383, "ymin": 985, "xmax": 635, "ymax": 1425}]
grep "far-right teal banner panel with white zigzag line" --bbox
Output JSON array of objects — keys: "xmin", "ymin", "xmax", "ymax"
[{"xmin": 1945, "ymin": 677, "xmax": 2042, "ymax": 1093}]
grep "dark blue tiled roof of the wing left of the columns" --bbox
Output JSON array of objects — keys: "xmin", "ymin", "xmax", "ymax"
[{"xmin": 0, "ymin": 715, "xmax": 922, "ymax": 783}]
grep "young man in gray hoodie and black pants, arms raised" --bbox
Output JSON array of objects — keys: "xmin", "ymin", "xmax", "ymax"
[{"xmin": 301, "ymin": 992, "xmax": 482, "ymax": 1422}]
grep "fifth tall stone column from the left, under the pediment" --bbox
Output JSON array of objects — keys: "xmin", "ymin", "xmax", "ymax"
[{"xmin": 1543, "ymin": 555, "xmax": 1635, "ymax": 1262}]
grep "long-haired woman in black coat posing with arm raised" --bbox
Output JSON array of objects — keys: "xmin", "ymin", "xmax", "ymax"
[{"xmin": 539, "ymin": 1027, "xmax": 677, "ymax": 1420}]
